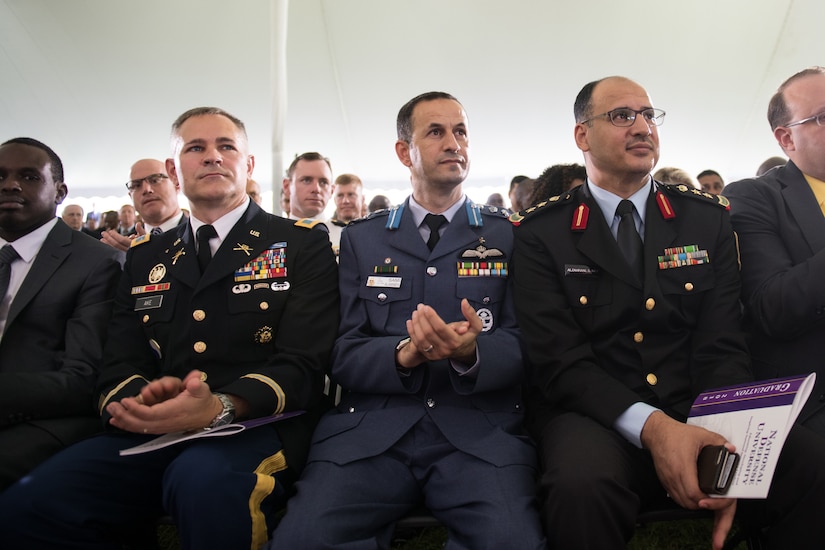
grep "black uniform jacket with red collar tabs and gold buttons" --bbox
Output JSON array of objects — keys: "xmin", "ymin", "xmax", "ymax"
[{"xmin": 513, "ymin": 182, "xmax": 751, "ymax": 428}]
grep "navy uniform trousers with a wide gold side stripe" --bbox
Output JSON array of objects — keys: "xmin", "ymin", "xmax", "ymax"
[{"xmin": 0, "ymin": 426, "xmax": 293, "ymax": 550}]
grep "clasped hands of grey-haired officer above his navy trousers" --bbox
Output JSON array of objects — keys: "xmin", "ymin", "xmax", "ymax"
[{"xmin": 106, "ymin": 370, "xmax": 223, "ymax": 434}]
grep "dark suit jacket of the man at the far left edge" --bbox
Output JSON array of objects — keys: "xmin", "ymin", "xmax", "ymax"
[{"xmin": 0, "ymin": 219, "xmax": 121, "ymax": 462}]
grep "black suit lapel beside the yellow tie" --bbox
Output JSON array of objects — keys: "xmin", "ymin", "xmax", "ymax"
[{"xmin": 776, "ymin": 161, "xmax": 825, "ymax": 253}]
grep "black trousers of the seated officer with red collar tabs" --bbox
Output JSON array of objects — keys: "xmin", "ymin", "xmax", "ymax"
[{"xmin": 537, "ymin": 413, "xmax": 825, "ymax": 550}]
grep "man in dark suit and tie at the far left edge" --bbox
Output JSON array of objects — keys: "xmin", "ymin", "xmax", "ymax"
[{"xmin": 0, "ymin": 138, "xmax": 120, "ymax": 490}]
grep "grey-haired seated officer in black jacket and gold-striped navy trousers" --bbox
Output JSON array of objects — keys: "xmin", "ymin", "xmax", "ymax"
[{"xmin": 0, "ymin": 107, "xmax": 338, "ymax": 548}]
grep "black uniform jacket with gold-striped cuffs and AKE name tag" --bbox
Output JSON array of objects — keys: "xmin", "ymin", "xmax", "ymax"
[{"xmin": 98, "ymin": 203, "xmax": 338, "ymax": 467}]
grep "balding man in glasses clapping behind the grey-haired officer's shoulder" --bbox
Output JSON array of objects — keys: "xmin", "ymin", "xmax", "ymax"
[{"xmin": 101, "ymin": 159, "xmax": 187, "ymax": 252}]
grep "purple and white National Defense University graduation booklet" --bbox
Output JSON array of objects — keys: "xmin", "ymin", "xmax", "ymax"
[{"xmin": 687, "ymin": 373, "xmax": 816, "ymax": 498}]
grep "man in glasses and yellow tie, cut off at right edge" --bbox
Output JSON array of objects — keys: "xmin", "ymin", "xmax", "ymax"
[{"xmin": 725, "ymin": 67, "xmax": 825, "ymax": 442}]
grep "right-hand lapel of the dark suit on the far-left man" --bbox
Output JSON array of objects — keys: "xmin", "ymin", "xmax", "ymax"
[{"xmin": 6, "ymin": 220, "xmax": 74, "ymax": 326}]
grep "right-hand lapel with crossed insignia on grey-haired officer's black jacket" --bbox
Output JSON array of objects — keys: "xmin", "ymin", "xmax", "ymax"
[{"xmin": 195, "ymin": 201, "xmax": 274, "ymax": 292}]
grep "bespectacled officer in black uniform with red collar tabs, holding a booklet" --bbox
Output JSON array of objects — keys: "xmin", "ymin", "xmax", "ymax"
[{"xmin": 511, "ymin": 77, "xmax": 825, "ymax": 549}]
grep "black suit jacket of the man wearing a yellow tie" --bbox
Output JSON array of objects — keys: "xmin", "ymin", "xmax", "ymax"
[{"xmin": 724, "ymin": 162, "xmax": 825, "ymax": 420}]
